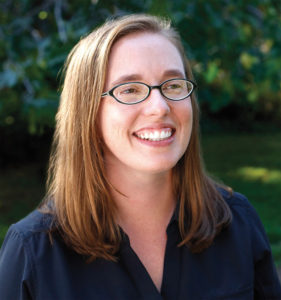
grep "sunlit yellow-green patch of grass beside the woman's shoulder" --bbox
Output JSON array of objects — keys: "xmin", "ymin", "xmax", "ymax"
[{"xmin": 230, "ymin": 166, "xmax": 281, "ymax": 184}]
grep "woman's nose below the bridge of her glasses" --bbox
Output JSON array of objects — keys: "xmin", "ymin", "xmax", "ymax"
[{"xmin": 143, "ymin": 89, "xmax": 168, "ymax": 117}]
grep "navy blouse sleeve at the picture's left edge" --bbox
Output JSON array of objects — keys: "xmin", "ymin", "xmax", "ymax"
[{"xmin": 0, "ymin": 226, "xmax": 34, "ymax": 300}]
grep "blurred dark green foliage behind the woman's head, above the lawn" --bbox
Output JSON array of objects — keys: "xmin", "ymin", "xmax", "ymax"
[{"xmin": 0, "ymin": 0, "xmax": 281, "ymax": 144}]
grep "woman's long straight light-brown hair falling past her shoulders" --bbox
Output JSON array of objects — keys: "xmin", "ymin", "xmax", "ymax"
[{"xmin": 46, "ymin": 15, "xmax": 231, "ymax": 260}]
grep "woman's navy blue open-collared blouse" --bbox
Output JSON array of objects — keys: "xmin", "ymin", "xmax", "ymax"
[{"xmin": 0, "ymin": 193, "xmax": 281, "ymax": 300}]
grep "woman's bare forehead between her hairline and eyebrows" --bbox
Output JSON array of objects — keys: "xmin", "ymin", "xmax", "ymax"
[{"xmin": 107, "ymin": 32, "xmax": 185, "ymax": 82}]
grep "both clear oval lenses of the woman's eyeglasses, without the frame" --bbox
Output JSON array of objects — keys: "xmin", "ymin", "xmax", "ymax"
[{"xmin": 113, "ymin": 79, "xmax": 193, "ymax": 103}]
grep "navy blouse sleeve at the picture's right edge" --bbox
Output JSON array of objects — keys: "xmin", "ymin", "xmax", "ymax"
[{"xmin": 245, "ymin": 202, "xmax": 281, "ymax": 299}]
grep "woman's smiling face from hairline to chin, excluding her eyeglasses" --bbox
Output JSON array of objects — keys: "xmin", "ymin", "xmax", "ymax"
[{"xmin": 99, "ymin": 33, "xmax": 192, "ymax": 175}]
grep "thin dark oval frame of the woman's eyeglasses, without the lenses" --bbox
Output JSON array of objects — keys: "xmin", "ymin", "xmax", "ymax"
[{"xmin": 101, "ymin": 78, "xmax": 197, "ymax": 105}]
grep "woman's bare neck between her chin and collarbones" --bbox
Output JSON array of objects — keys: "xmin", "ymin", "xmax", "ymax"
[{"xmin": 105, "ymin": 166, "xmax": 176, "ymax": 231}]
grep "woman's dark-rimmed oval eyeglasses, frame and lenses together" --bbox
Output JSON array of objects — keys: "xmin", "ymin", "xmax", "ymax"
[{"xmin": 102, "ymin": 79, "xmax": 196, "ymax": 105}]
